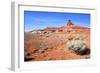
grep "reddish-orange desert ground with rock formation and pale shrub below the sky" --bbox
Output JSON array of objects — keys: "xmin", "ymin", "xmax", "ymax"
[{"xmin": 24, "ymin": 21, "xmax": 91, "ymax": 62}]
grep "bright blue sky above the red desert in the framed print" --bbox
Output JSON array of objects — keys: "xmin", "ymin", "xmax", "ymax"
[{"xmin": 24, "ymin": 11, "xmax": 90, "ymax": 31}]
